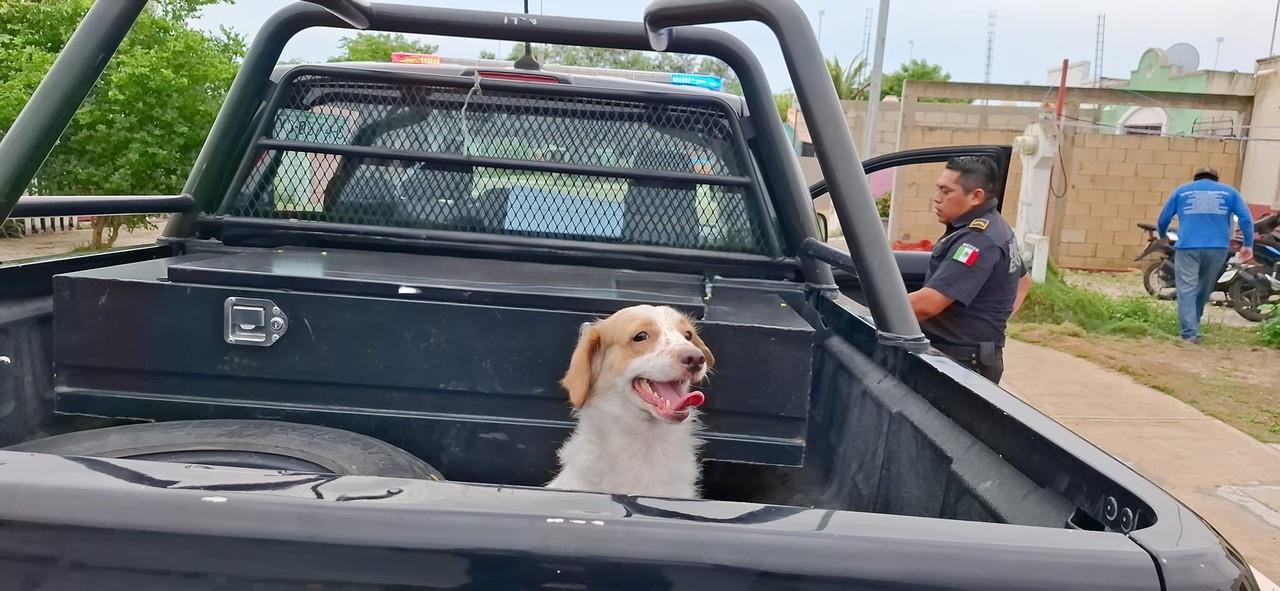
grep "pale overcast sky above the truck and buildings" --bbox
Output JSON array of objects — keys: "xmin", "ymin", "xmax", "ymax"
[{"xmin": 198, "ymin": 0, "xmax": 1280, "ymax": 91}]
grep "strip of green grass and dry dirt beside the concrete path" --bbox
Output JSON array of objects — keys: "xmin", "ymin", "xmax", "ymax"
[{"xmin": 1009, "ymin": 270, "xmax": 1280, "ymax": 443}]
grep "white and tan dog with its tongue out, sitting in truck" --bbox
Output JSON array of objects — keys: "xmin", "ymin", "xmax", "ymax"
[{"xmin": 547, "ymin": 306, "xmax": 716, "ymax": 499}]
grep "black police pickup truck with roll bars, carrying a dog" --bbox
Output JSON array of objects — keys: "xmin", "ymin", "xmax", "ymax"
[{"xmin": 0, "ymin": 0, "xmax": 1257, "ymax": 591}]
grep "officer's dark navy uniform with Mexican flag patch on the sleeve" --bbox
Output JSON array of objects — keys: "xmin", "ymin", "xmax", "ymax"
[{"xmin": 920, "ymin": 201, "xmax": 1027, "ymax": 382}]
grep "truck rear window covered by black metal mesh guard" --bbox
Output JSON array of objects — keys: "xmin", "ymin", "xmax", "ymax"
[{"xmin": 219, "ymin": 68, "xmax": 772, "ymax": 253}]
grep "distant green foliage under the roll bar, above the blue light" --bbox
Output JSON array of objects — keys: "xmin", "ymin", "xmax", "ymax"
[{"xmin": 507, "ymin": 43, "xmax": 742, "ymax": 95}]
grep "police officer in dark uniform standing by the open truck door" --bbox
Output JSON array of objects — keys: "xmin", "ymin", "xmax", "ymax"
[{"xmin": 910, "ymin": 156, "xmax": 1030, "ymax": 382}]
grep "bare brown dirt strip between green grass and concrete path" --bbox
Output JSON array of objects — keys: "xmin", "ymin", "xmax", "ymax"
[{"xmin": 1010, "ymin": 325, "xmax": 1280, "ymax": 444}]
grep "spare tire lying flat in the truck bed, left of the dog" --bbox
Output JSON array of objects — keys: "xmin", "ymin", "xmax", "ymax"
[{"xmin": 5, "ymin": 420, "xmax": 444, "ymax": 480}]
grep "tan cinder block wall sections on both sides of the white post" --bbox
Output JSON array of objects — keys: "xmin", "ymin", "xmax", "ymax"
[{"xmin": 801, "ymin": 102, "xmax": 1243, "ymax": 269}]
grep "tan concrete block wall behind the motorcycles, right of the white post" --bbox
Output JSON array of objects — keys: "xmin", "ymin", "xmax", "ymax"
[{"xmin": 1053, "ymin": 133, "xmax": 1240, "ymax": 269}]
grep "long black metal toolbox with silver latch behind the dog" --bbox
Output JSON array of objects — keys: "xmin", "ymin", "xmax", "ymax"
[{"xmin": 54, "ymin": 248, "xmax": 814, "ymax": 484}]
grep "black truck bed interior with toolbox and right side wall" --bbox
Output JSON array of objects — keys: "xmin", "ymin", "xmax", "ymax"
[{"xmin": 54, "ymin": 248, "xmax": 1131, "ymax": 530}]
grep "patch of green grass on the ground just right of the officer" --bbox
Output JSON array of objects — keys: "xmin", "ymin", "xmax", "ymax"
[{"xmin": 1014, "ymin": 272, "xmax": 1179, "ymax": 338}]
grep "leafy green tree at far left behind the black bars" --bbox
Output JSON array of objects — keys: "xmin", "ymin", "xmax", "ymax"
[{"xmin": 0, "ymin": 0, "xmax": 244, "ymax": 248}]
